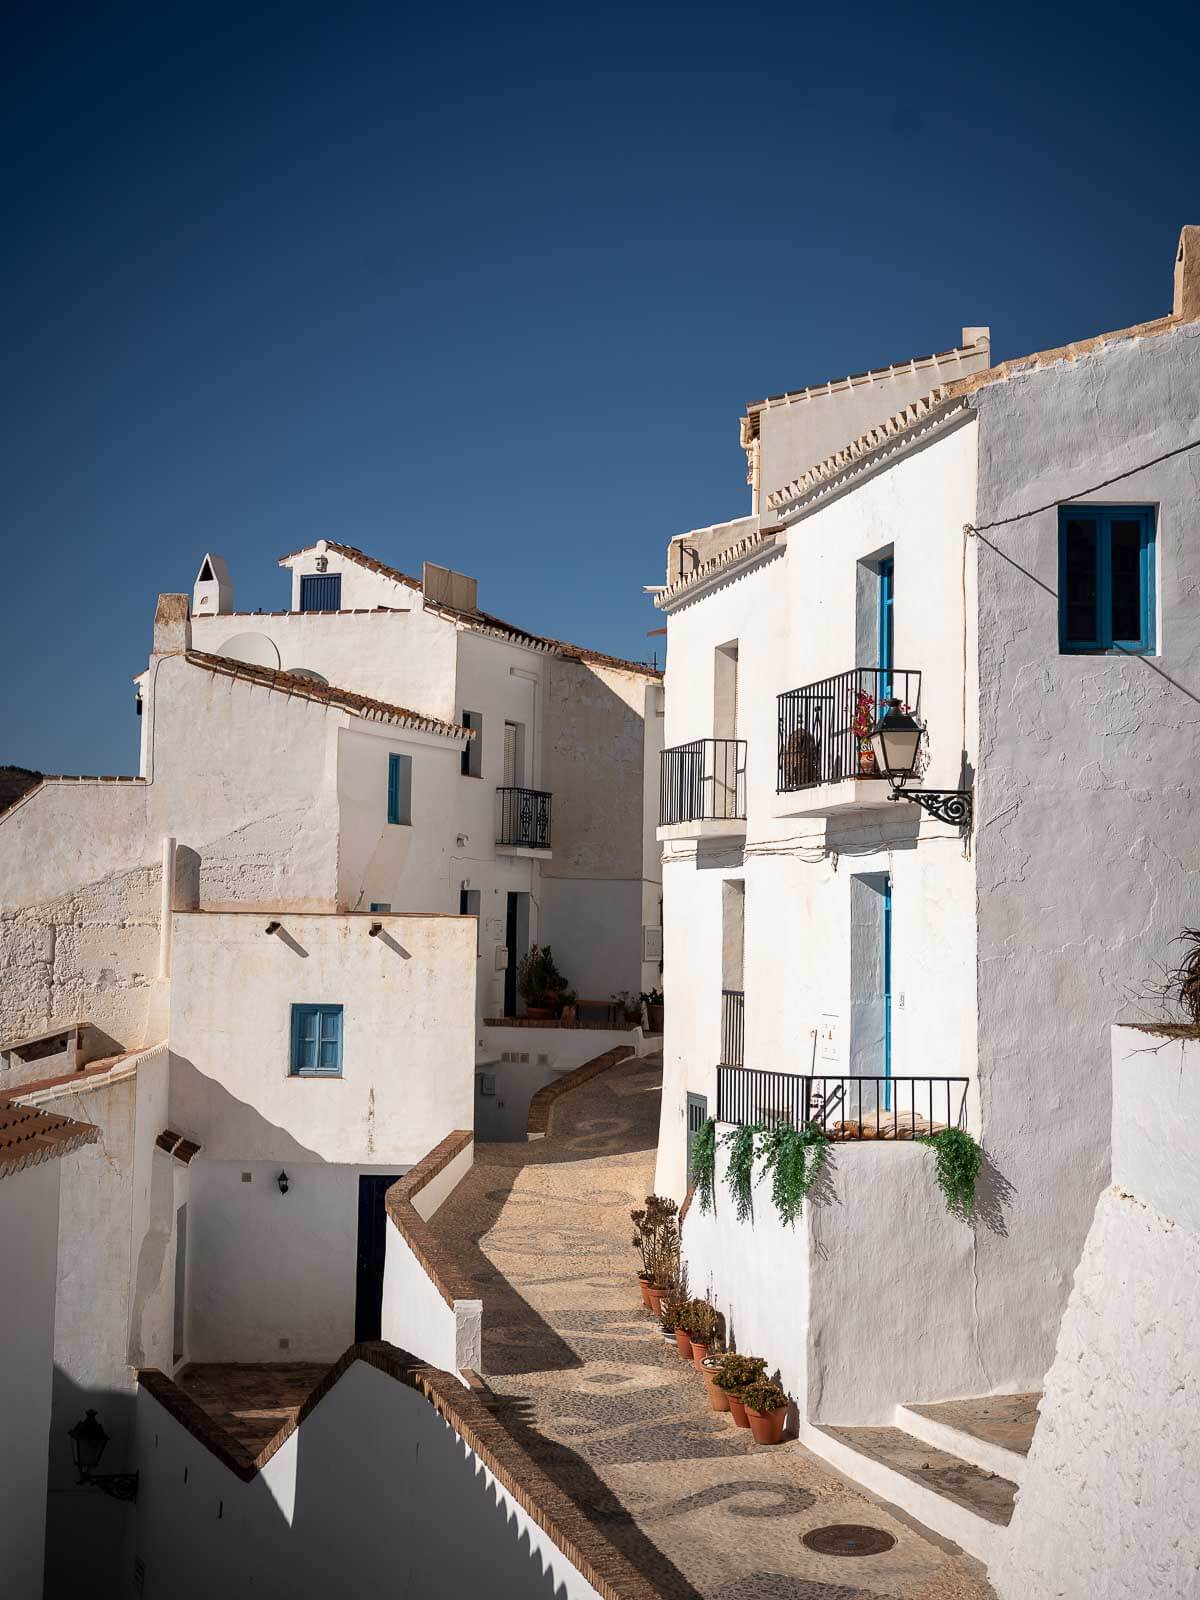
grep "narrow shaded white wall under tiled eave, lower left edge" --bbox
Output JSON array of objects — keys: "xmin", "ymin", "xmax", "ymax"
[{"xmin": 0, "ymin": 1160, "xmax": 59, "ymax": 1600}]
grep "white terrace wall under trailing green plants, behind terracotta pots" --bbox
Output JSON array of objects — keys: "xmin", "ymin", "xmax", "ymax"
[{"xmin": 683, "ymin": 1128, "xmax": 997, "ymax": 1427}]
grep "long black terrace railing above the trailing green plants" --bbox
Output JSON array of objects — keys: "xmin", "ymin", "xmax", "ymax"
[{"xmin": 717, "ymin": 1066, "xmax": 968, "ymax": 1139}]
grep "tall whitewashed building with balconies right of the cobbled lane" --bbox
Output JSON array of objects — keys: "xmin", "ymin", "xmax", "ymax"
[{"xmin": 654, "ymin": 229, "xmax": 1200, "ymax": 1557}]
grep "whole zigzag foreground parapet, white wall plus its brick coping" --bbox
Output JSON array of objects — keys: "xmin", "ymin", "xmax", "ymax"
[{"xmin": 136, "ymin": 1347, "xmax": 651, "ymax": 1600}]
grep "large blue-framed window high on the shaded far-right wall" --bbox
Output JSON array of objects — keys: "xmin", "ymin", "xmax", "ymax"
[{"xmin": 1058, "ymin": 506, "xmax": 1155, "ymax": 656}]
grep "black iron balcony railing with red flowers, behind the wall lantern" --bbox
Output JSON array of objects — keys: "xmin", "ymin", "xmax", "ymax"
[{"xmin": 776, "ymin": 667, "xmax": 922, "ymax": 794}]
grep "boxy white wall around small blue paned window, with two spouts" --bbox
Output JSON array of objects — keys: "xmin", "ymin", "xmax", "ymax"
[{"xmin": 170, "ymin": 912, "xmax": 475, "ymax": 1168}]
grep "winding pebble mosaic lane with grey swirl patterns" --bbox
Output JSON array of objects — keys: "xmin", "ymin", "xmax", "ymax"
[{"xmin": 432, "ymin": 1059, "xmax": 992, "ymax": 1600}]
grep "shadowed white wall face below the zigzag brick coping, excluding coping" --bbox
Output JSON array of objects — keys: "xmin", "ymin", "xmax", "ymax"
[{"xmin": 138, "ymin": 1362, "xmax": 611, "ymax": 1600}]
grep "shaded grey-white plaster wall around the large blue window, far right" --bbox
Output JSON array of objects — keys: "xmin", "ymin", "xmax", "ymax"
[{"xmin": 974, "ymin": 325, "xmax": 1200, "ymax": 1389}]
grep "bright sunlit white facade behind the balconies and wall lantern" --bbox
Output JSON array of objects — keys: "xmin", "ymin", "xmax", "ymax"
[{"xmin": 656, "ymin": 422, "xmax": 978, "ymax": 1197}]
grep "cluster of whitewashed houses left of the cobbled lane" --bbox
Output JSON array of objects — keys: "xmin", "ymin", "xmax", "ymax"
[{"xmin": 0, "ymin": 542, "xmax": 662, "ymax": 1592}]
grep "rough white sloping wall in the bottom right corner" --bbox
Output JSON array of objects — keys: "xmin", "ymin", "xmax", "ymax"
[{"xmin": 990, "ymin": 1027, "xmax": 1200, "ymax": 1600}]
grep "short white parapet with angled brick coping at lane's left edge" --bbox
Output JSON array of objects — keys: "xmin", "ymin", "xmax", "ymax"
[{"xmin": 381, "ymin": 1130, "xmax": 483, "ymax": 1378}]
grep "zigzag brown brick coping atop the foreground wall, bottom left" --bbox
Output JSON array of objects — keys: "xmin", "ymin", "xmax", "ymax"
[{"xmin": 138, "ymin": 1339, "xmax": 658, "ymax": 1600}]
